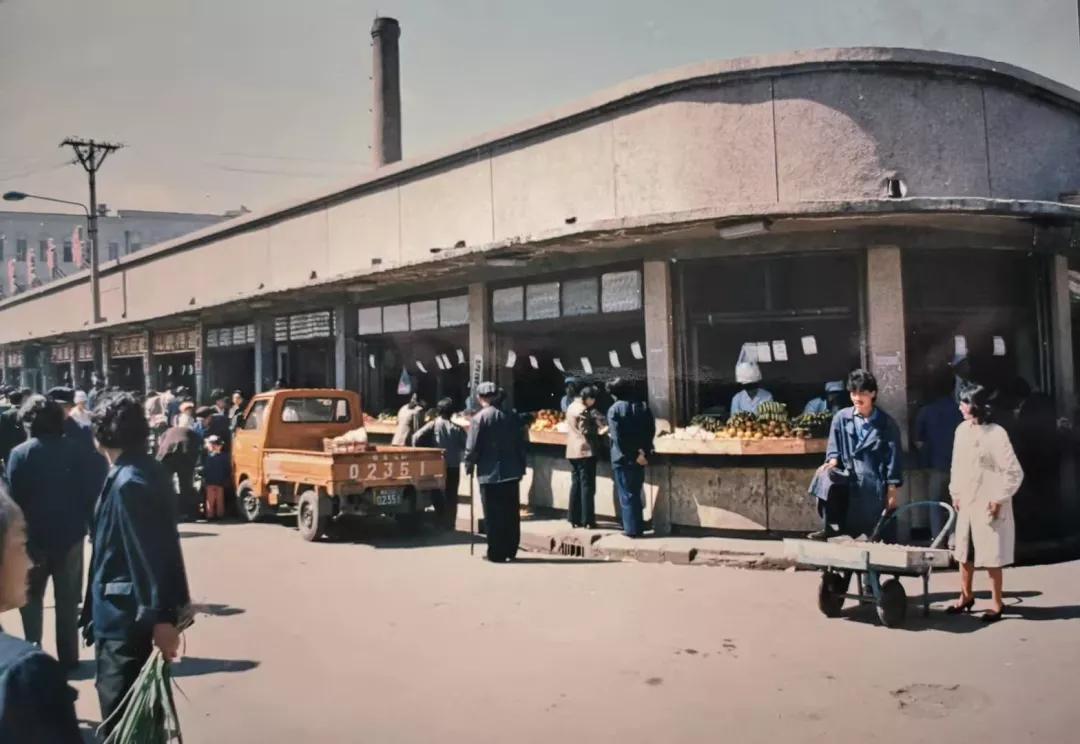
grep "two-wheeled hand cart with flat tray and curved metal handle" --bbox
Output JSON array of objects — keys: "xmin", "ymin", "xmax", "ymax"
[{"xmin": 784, "ymin": 501, "xmax": 956, "ymax": 627}]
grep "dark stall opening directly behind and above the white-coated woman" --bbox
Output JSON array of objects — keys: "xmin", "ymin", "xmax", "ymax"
[{"xmin": 904, "ymin": 251, "xmax": 1052, "ymax": 411}]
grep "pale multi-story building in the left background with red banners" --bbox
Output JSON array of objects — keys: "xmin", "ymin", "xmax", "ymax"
[{"xmin": 0, "ymin": 205, "xmax": 241, "ymax": 295}]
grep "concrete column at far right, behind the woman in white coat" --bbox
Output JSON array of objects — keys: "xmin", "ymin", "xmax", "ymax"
[{"xmin": 1050, "ymin": 255, "xmax": 1080, "ymax": 525}]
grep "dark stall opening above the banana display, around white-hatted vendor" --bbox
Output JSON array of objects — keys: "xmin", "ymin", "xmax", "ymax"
[{"xmin": 678, "ymin": 254, "xmax": 862, "ymax": 419}]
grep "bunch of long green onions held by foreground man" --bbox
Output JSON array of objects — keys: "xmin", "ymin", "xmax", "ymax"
[{"xmin": 97, "ymin": 609, "xmax": 193, "ymax": 744}]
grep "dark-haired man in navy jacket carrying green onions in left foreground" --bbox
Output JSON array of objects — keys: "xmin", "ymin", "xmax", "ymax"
[{"xmin": 80, "ymin": 393, "xmax": 190, "ymax": 734}]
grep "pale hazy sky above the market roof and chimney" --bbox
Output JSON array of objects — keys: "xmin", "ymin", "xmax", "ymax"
[{"xmin": 0, "ymin": 0, "xmax": 1080, "ymax": 213}]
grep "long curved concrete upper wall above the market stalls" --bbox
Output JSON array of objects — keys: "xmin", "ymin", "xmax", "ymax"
[{"xmin": 0, "ymin": 50, "xmax": 1080, "ymax": 343}]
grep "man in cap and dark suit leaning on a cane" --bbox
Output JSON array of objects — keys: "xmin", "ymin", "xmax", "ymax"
[{"xmin": 464, "ymin": 382, "xmax": 526, "ymax": 563}]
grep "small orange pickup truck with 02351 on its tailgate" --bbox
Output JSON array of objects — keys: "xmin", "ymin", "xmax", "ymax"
[{"xmin": 232, "ymin": 389, "xmax": 446, "ymax": 540}]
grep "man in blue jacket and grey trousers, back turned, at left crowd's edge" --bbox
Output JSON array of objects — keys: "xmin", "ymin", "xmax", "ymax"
[{"xmin": 8, "ymin": 395, "xmax": 96, "ymax": 668}]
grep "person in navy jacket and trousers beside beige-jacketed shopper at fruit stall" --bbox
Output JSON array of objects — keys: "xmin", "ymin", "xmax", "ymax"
[{"xmin": 608, "ymin": 378, "xmax": 657, "ymax": 538}]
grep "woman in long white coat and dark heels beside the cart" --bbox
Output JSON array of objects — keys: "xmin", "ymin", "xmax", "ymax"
[{"xmin": 945, "ymin": 385, "xmax": 1024, "ymax": 623}]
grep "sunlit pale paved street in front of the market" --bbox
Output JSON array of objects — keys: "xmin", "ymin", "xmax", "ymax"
[{"xmin": 2, "ymin": 524, "xmax": 1080, "ymax": 744}]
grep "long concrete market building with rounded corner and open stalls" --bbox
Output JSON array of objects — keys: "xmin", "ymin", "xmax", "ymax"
[{"xmin": 0, "ymin": 37, "xmax": 1080, "ymax": 531}]
